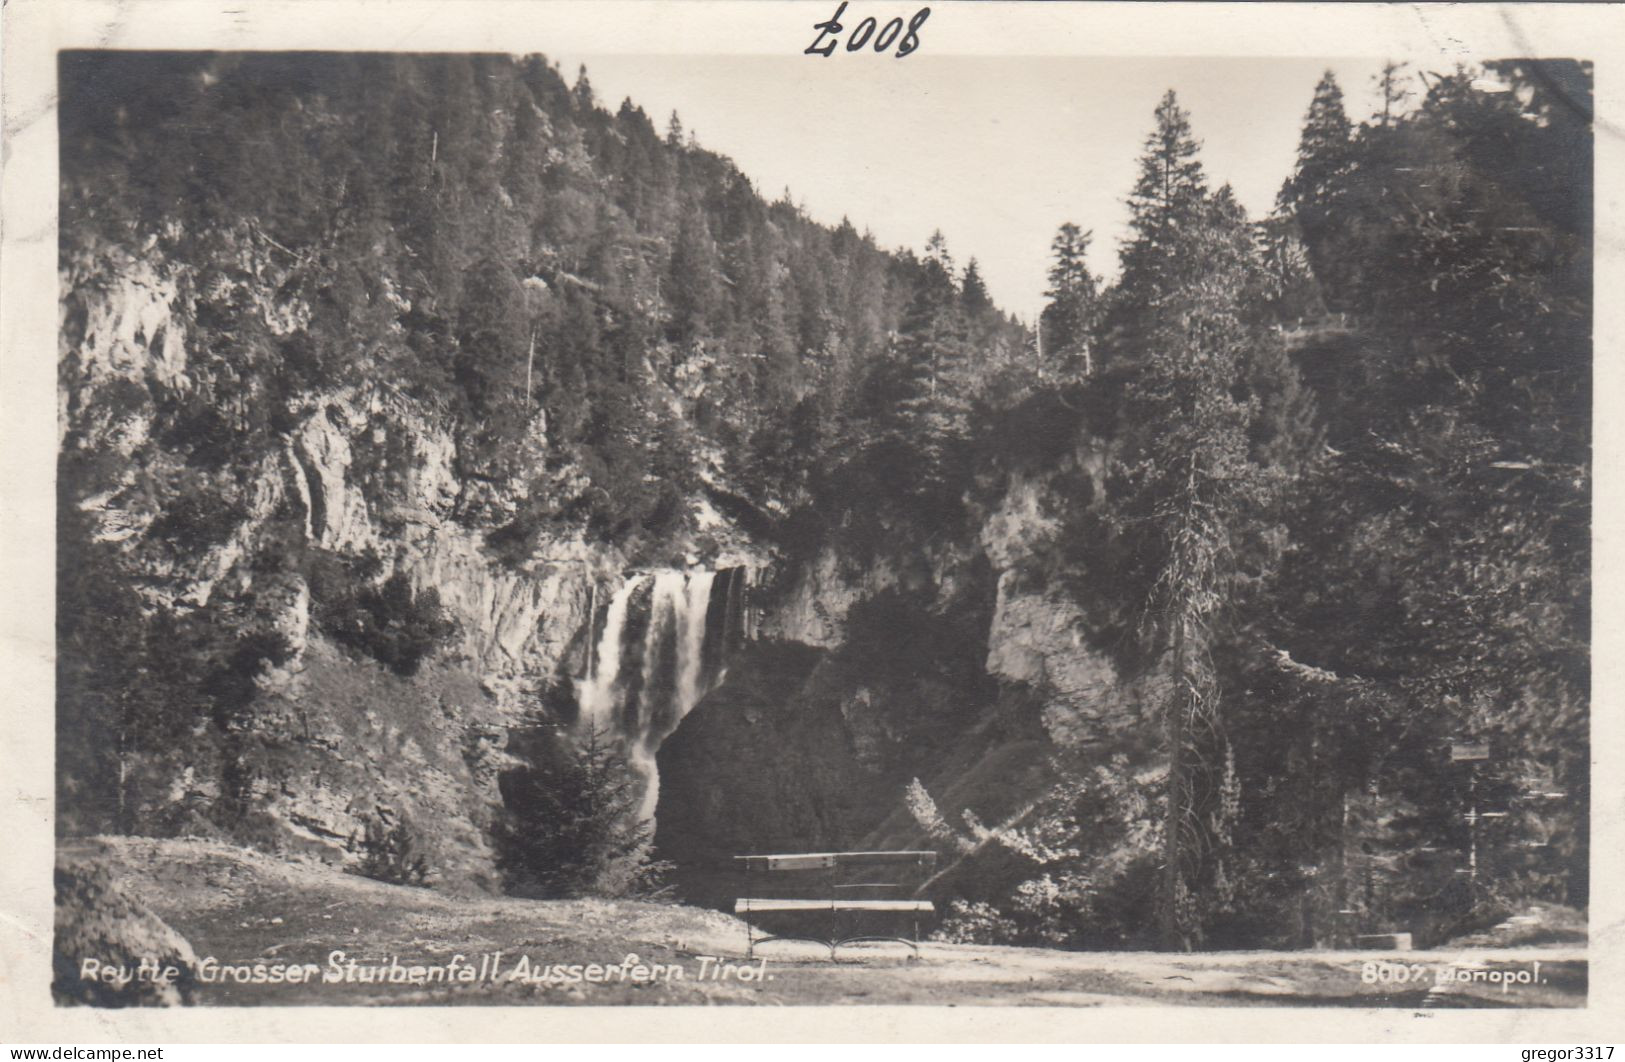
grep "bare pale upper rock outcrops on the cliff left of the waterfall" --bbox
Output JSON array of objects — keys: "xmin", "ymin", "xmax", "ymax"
[{"xmin": 59, "ymin": 233, "xmax": 624, "ymax": 692}]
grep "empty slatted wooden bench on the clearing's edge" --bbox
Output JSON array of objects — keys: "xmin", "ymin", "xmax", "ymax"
[{"xmin": 733, "ymin": 851, "xmax": 936, "ymax": 960}]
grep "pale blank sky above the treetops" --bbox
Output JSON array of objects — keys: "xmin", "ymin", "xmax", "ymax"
[{"xmin": 553, "ymin": 54, "xmax": 1381, "ymax": 318}]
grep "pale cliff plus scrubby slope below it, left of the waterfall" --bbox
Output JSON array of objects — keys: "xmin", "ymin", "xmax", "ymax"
[{"xmin": 59, "ymin": 235, "xmax": 754, "ymax": 887}]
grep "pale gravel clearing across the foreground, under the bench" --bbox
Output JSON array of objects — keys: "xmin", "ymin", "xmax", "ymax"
[{"xmin": 59, "ymin": 838, "xmax": 1586, "ymax": 1010}]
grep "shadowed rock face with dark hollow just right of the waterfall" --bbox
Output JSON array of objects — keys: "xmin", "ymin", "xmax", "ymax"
[{"xmin": 657, "ymin": 451, "xmax": 1162, "ymax": 906}]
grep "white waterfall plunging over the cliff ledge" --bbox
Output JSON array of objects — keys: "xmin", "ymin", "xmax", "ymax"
[{"xmin": 577, "ymin": 568, "xmax": 744, "ymax": 818}]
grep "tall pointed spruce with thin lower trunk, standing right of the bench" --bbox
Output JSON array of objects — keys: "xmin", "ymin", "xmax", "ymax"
[{"xmin": 1120, "ymin": 93, "xmax": 1264, "ymax": 950}]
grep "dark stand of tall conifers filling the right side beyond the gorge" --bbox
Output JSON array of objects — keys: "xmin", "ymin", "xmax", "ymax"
[{"xmin": 890, "ymin": 62, "xmax": 1591, "ymax": 947}]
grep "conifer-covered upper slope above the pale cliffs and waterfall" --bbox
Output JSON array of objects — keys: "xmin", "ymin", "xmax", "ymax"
[{"xmin": 62, "ymin": 55, "xmax": 1017, "ymax": 549}]
